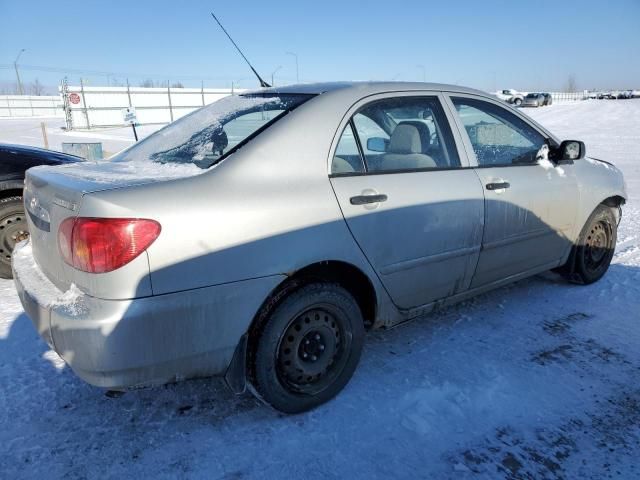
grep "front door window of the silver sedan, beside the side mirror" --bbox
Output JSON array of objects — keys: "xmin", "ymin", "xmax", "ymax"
[{"xmin": 451, "ymin": 98, "xmax": 546, "ymax": 166}]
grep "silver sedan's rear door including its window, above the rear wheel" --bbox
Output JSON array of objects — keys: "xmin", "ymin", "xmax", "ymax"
[{"xmin": 331, "ymin": 93, "xmax": 484, "ymax": 308}]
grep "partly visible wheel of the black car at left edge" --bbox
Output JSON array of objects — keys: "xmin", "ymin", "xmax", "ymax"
[{"xmin": 0, "ymin": 197, "xmax": 29, "ymax": 278}]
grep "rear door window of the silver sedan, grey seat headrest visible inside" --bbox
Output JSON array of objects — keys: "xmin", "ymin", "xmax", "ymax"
[{"xmin": 334, "ymin": 97, "xmax": 460, "ymax": 172}]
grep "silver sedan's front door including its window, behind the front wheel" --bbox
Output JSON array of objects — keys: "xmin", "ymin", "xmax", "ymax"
[{"xmin": 450, "ymin": 94, "xmax": 579, "ymax": 288}]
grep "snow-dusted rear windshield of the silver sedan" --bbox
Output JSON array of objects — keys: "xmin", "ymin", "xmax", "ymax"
[{"xmin": 112, "ymin": 94, "xmax": 312, "ymax": 169}]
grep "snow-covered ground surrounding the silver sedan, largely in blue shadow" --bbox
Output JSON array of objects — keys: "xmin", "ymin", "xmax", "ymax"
[{"xmin": 0, "ymin": 100, "xmax": 640, "ymax": 479}]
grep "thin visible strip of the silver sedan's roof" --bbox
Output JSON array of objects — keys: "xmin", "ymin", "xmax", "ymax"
[{"xmin": 251, "ymin": 82, "xmax": 487, "ymax": 95}]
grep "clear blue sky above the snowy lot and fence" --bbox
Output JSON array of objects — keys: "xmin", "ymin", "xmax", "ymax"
[{"xmin": 0, "ymin": 0, "xmax": 640, "ymax": 90}]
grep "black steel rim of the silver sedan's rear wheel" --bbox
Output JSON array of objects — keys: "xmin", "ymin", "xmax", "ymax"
[{"xmin": 276, "ymin": 305, "xmax": 349, "ymax": 395}]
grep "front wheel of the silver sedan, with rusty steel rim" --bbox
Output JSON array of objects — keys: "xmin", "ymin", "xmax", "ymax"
[{"xmin": 557, "ymin": 205, "xmax": 618, "ymax": 285}]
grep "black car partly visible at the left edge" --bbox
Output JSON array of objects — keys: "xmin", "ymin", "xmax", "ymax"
[{"xmin": 0, "ymin": 143, "xmax": 84, "ymax": 278}]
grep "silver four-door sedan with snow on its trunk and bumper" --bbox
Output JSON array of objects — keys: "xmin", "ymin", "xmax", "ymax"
[{"xmin": 13, "ymin": 83, "xmax": 625, "ymax": 412}]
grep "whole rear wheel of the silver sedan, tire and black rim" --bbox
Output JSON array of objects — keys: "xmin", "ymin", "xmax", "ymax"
[{"xmin": 248, "ymin": 283, "xmax": 364, "ymax": 413}]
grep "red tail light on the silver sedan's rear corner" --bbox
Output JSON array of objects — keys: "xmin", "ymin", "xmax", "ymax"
[{"xmin": 58, "ymin": 217, "xmax": 161, "ymax": 273}]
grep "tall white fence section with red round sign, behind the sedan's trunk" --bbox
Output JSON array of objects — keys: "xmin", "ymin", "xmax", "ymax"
[{"xmin": 61, "ymin": 85, "xmax": 241, "ymax": 129}]
